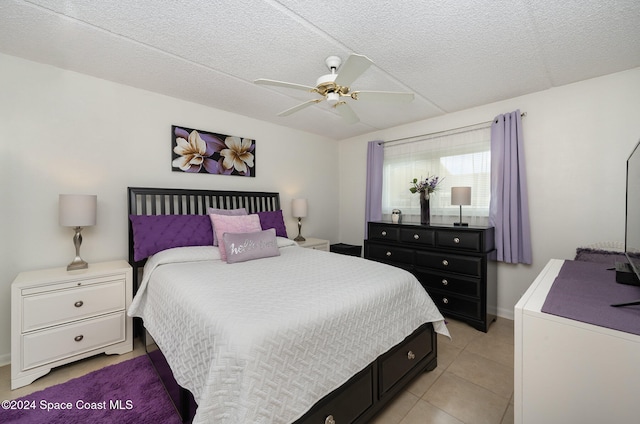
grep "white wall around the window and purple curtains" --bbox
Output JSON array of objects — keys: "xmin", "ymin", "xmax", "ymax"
[{"xmin": 339, "ymin": 68, "xmax": 640, "ymax": 319}]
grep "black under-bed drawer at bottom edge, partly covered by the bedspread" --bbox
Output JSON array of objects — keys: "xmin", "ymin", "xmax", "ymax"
[{"xmin": 296, "ymin": 365, "xmax": 373, "ymax": 424}]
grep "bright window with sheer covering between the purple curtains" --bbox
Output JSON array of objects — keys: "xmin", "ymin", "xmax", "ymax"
[{"xmin": 382, "ymin": 125, "xmax": 491, "ymax": 225}]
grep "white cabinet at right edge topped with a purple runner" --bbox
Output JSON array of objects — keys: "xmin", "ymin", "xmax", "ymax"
[{"xmin": 514, "ymin": 259, "xmax": 640, "ymax": 424}]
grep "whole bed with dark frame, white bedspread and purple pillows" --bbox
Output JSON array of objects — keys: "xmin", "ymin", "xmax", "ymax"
[{"xmin": 128, "ymin": 187, "xmax": 448, "ymax": 424}]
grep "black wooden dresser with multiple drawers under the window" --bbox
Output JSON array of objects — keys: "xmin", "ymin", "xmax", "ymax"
[{"xmin": 364, "ymin": 222, "xmax": 498, "ymax": 332}]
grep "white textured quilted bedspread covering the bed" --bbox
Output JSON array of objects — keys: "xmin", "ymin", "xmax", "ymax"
[{"xmin": 129, "ymin": 239, "xmax": 448, "ymax": 424}]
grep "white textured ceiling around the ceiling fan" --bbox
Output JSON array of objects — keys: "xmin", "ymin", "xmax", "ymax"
[{"xmin": 0, "ymin": 0, "xmax": 640, "ymax": 139}]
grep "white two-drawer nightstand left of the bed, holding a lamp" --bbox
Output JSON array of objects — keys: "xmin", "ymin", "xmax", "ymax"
[{"xmin": 11, "ymin": 261, "xmax": 133, "ymax": 390}]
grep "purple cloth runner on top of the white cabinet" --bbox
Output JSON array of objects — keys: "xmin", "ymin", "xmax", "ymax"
[{"xmin": 542, "ymin": 261, "xmax": 640, "ymax": 335}]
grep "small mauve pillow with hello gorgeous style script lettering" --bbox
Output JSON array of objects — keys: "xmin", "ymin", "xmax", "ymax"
[{"xmin": 222, "ymin": 228, "xmax": 280, "ymax": 264}]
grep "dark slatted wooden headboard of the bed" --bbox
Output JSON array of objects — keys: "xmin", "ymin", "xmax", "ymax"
[{"xmin": 127, "ymin": 187, "xmax": 280, "ymax": 284}]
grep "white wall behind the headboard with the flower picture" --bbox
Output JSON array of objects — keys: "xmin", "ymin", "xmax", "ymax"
[{"xmin": 0, "ymin": 55, "xmax": 338, "ymax": 364}]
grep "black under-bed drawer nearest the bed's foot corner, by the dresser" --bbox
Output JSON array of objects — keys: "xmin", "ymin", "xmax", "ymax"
[{"xmin": 380, "ymin": 324, "xmax": 433, "ymax": 396}]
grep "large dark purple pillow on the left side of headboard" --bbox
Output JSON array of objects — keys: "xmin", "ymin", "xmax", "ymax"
[{"xmin": 129, "ymin": 215, "xmax": 213, "ymax": 262}]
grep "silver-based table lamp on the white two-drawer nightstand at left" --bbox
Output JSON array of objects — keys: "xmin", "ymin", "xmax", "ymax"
[{"xmin": 58, "ymin": 194, "xmax": 98, "ymax": 271}]
